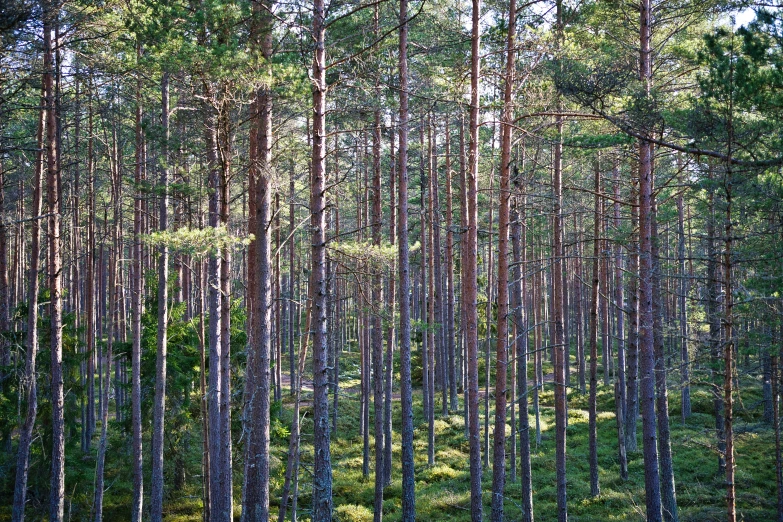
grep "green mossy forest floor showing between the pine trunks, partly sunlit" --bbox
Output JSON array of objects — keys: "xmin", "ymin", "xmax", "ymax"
[{"xmin": 0, "ymin": 353, "xmax": 777, "ymax": 522}]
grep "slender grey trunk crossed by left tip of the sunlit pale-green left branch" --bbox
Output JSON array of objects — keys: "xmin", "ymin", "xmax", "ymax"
[{"xmin": 150, "ymin": 72, "xmax": 169, "ymax": 522}]
